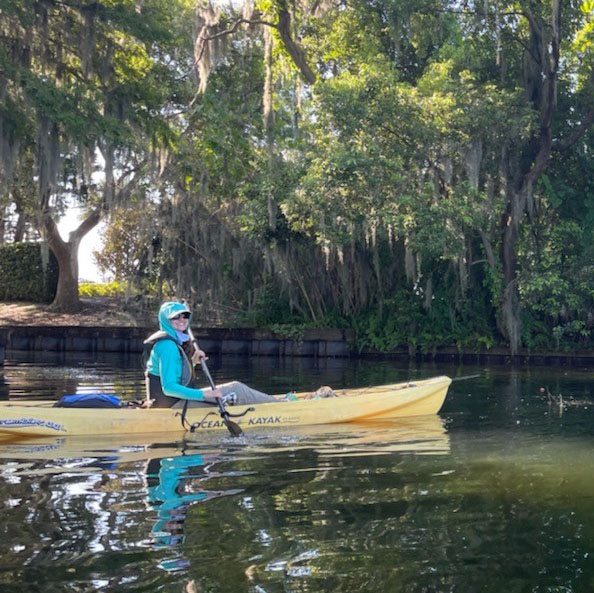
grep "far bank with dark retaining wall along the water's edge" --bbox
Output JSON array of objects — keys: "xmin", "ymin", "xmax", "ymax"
[{"xmin": 0, "ymin": 298, "xmax": 594, "ymax": 366}]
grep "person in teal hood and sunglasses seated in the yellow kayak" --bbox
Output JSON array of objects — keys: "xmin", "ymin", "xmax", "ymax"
[{"xmin": 144, "ymin": 301, "xmax": 279, "ymax": 408}]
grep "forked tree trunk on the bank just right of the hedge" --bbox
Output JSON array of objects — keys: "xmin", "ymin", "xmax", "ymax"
[{"xmin": 43, "ymin": 210, "xmax": 101, "ymax": 313}]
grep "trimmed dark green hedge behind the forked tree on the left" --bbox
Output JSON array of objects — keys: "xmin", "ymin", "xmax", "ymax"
[{"xmin": 0, "ymin": 243, "xmax": 58, "ymax": 303}]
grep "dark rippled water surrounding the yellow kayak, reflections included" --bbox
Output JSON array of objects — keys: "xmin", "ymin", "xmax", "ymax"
[{"xmin": 0, "ymin": 356, "xmax": 594, "ymax": 593}]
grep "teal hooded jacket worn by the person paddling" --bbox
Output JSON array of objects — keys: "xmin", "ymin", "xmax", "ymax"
[{"xmin": 146, "ymin": 301, "xmax": 204, "ymax": 401}]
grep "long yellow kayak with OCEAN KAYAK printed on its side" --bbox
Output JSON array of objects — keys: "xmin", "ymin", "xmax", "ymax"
[{"xmin": 0, "ymin": 376, "xmax": 452, "ymax": 438}]
